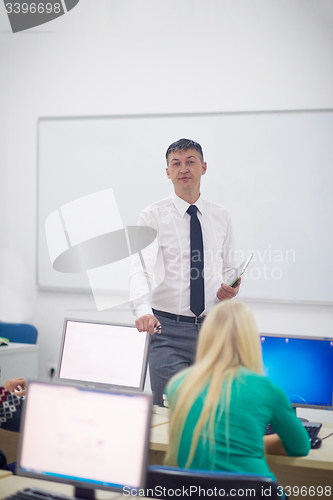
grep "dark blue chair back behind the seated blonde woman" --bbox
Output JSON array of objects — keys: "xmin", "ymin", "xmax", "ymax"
[{"xmin": 146, "ymin": 465, "xmax": 281, "ymax": 500}]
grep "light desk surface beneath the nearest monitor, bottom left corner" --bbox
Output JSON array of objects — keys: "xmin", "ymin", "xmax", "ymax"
[{"xmin": 0, "ymin": 476, "xmax": 118, "ymax": 500}]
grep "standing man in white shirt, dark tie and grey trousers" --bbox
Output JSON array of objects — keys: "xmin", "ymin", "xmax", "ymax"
[{"xmin": 132, "ymin": 139, "xmax": 240, "ymax": 405}]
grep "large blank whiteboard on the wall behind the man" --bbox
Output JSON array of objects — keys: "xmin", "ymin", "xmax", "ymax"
[{"xmin": 37, "ymin": 110, "xmax": 333, "ymax": 304}]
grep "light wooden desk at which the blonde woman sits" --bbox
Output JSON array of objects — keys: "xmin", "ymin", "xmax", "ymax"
[{"xmin": 149, "ymin": 423, "xmax": 333, "ymax": 500}]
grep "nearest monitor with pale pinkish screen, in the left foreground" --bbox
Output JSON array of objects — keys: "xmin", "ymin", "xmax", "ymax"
[{"xmin": 17, "ymin": 382, "xmax": 152, "ymax": 498}]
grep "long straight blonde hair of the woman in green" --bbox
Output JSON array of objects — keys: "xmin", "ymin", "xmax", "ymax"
[{"xmin": 165, "ymin": 300, "xmax": 262, "ymax": 467}]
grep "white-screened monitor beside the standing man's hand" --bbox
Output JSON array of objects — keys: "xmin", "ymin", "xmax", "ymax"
[{"xmin": 56, "ymin": 318, "xmax": 150, "ymax": 392}]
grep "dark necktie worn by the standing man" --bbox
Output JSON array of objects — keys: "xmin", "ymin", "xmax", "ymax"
[{"xmin": 187, "ymin": 205, "xmax": 205, "ymax": 316}]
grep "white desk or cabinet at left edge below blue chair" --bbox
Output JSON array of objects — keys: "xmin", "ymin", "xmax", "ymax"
[{"xmin": 0, "ymin": 342, "xmax": 38, "ymax": 385}]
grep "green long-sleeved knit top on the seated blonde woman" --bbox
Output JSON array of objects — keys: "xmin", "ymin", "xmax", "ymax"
[{"xmin": 166, "ymin": 367, "xmax": 310, "ymax": 479}]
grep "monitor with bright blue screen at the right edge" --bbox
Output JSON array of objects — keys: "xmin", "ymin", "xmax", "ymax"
[{"xmin": 260, "ymin": 333, "xmax": 333, "ymax": 410}]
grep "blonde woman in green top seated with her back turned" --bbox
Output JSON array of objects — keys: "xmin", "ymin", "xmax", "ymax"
[{"xmin": 166, "ymin": 301, "xmax": 310, "ymax": 478}]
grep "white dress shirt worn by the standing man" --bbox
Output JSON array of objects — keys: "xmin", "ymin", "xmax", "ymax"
[{"xmin": 130, "ymin": 193, "xmax": 237, "ymax": 317}]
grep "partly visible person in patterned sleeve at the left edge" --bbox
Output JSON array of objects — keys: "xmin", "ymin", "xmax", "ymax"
[{"xmin": 0, "ymin": 378, "xmax": 26, "ymax": 432}]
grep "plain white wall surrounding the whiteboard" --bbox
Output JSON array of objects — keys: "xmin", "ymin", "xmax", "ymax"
[{"xmin": 0, "ymin": 0, "xmax": 333, "ymax": 418}]
